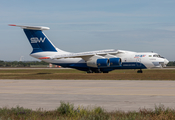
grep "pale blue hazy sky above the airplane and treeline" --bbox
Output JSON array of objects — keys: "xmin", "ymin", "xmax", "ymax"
[{"xmin": 0, "ymin": 0, "xmax": 175, "ymax": 61}]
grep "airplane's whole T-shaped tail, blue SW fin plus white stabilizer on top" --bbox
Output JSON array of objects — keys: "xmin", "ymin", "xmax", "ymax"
[{"xmin": 9, "ymin": 24, "xmax": 57, "ymax": 53}]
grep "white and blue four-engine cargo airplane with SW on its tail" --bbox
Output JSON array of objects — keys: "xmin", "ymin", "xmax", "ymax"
[{"xmin": 9, "ymin": 24, "xmax": 169, "ymax": 73}]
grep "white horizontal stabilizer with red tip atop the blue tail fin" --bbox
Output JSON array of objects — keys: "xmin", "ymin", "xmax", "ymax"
[{"xmin": 9, "ymin": 24, "xmax": 50, "ymax": 30}]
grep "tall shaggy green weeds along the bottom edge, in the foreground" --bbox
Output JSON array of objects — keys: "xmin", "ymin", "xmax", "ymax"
[{"xmin": 0, "ymin": 102, "xmax": 175, "ymax": 120}]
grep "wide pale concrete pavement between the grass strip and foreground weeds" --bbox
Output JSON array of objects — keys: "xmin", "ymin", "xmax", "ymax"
[{"xmin": 0, "ymin": 80, "xmax": 175, "ymax": 111}]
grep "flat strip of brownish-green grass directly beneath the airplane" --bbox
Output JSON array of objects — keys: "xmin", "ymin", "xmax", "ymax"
[{"xmin": 0, "ymin": 69, "xmax": 175, "ymax": 80}]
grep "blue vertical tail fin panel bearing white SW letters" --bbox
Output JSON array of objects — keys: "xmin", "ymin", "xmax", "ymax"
[{"xmin": 24, "ymin": 29, "xmax": 57, "ymax": 53}]
